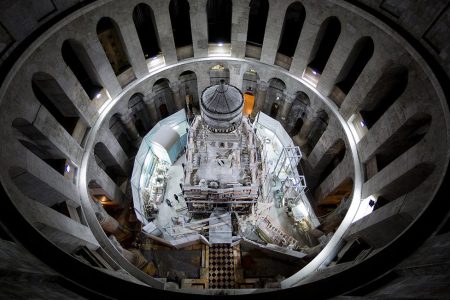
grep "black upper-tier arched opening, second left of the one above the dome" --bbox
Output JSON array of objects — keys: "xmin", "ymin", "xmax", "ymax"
[{"xmin": 133, "ymin": 3, "xmax": 161, "ymax": 59}]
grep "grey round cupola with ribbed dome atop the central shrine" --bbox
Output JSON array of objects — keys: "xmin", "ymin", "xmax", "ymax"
[{"xmin": 200, "ymin": 80, "xmax": 244, "ymax": 132}]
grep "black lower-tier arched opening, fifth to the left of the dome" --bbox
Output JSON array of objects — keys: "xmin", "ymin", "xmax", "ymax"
[{"xmin": 94, "ymin": 142, "xmax": 127, "ymax": 186}]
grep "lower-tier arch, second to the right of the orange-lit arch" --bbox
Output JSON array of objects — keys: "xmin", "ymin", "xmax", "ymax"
[{"xmin": 285, "ymin": 91, "xmax": 311, "ymax": 136}]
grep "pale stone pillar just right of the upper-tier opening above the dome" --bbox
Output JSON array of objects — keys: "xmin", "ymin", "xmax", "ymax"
[{"xmin": 231, "ymin": 0, "xmax": 250, "ymax": 58}]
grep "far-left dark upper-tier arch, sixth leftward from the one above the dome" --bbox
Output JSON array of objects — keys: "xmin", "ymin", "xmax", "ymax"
[{"xmin": 12, "ymin": 118, "xmax": 67, "ymax": 175}]
